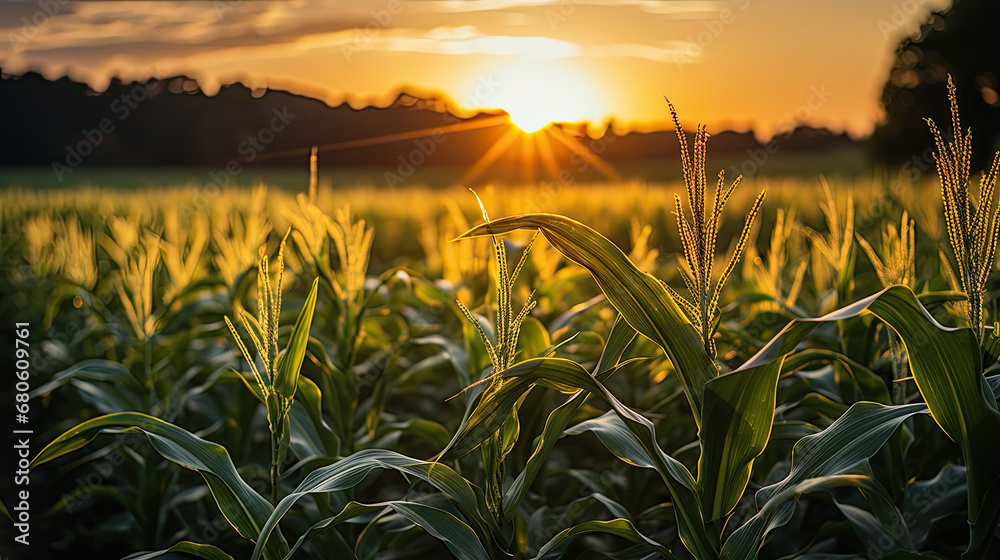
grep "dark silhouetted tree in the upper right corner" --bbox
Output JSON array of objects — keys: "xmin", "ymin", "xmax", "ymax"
[{"xmin": 872, "ymin": 0, "xmax": 1000, "ymax": 169}]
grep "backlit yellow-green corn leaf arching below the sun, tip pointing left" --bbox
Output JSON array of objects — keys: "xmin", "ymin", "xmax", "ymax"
[{"xmin": 458, "ymin": 214, "xmax": 718, "ymax": 425}]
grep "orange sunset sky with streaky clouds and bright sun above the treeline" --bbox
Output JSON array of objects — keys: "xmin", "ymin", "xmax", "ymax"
[{"xmin": 0, "ymin": 0, "xmax": 950, "ymax": 137}]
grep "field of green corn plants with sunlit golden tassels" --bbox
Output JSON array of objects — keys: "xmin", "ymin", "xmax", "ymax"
[{"xmin": 0, "ymin": 80, "xmax": 1000, "ymax": 560}]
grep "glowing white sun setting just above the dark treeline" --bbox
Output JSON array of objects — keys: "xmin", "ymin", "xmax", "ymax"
[{"xmin": 464, "ymin": 61, "xmax": 603, "ymax": 134}]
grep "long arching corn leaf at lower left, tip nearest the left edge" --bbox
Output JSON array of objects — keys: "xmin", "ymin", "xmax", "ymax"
[{"xmin": 31, "ymin": 412, "xmax": 288, "ymax": 558}]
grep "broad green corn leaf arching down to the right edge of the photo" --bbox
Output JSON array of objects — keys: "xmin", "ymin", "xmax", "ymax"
[{"xmin": 698, "ymin": 286, "xmax": 1000, "ymax": 549}]
